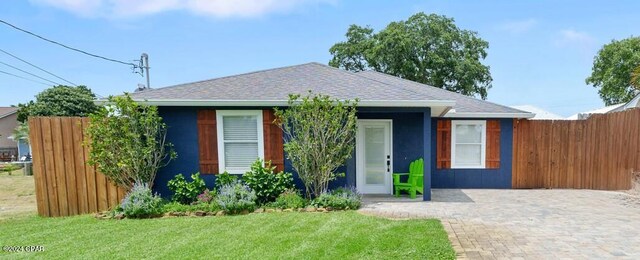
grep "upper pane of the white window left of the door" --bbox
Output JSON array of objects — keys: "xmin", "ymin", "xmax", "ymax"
[{"xmin": 222, "ymin": 116, "xmax": 258, "ymax": 140}]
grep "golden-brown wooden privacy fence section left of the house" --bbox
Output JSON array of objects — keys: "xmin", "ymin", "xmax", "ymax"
[{"xmin": 29, "ymin": 117, "xmax": 125, "ymax": 217}]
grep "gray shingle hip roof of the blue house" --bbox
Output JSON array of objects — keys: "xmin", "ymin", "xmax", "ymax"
[{"xmin": 131, "ymin": 62, "xmax": 526, "ymax": 113}]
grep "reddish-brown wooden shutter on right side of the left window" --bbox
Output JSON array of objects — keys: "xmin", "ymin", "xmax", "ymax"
[{"xmin": 262, "ymin": 109, "xmax": 284, "ymax": 172}]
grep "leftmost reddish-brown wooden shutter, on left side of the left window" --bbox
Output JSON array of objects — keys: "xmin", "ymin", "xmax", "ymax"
[{"xmin": 198, "ymin": 110, "xmax": 218, "ymax": 174}]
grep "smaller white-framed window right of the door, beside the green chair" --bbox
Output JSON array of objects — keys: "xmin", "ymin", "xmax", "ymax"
[{"xmin": 451, "ymin": 120, "xmax": 487, "ymax": 168}]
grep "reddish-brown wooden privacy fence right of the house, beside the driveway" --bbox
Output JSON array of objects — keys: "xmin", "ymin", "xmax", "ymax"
[{"xmin": 512, "ymin": 109, "xmax": 640, "ymax": 190}]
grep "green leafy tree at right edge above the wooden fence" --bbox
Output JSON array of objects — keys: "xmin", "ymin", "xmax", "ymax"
[{"xmin": 585, "ymin": 37, "xmax": 640, "ymax": 105}]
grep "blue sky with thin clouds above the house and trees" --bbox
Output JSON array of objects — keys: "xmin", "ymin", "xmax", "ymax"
[{"xmin": 0, "ymin": 0, "xmax": 640, "ymax": 116}]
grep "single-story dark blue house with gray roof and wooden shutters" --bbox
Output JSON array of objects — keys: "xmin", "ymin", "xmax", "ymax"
[{"xmin": 131, "ymin": 63, "xmax": 534, "ymax": 200}]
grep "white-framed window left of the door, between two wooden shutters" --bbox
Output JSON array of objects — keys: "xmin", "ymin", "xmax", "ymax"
[{"xmin": 216, "ymin": 110, "xmax": 264, "ymax": 174}]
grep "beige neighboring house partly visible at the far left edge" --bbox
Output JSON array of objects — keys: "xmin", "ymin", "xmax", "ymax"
[{"xmin": 0, "ymin": 107, "xmax": 18, "ymax": 162}]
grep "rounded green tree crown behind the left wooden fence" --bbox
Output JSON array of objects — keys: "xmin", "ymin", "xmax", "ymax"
[{"xmin": 18, "ymin": 85, "xmax": 98, "ymax": 122}]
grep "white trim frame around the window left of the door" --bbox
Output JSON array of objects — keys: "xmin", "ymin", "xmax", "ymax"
[{"xmin": 216, "ymin": 110, "xmax": 264, "ymax": 174}]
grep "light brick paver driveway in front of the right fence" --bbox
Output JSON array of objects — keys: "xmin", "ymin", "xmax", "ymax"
[{"xmin": 360, "ymin": 190, "xmax": 640, "ymax": 259}]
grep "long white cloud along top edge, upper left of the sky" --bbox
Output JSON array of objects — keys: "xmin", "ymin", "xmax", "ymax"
[{"xmin": 31, "ymin": 0, "xmax": 335, "ymax": 18}]
